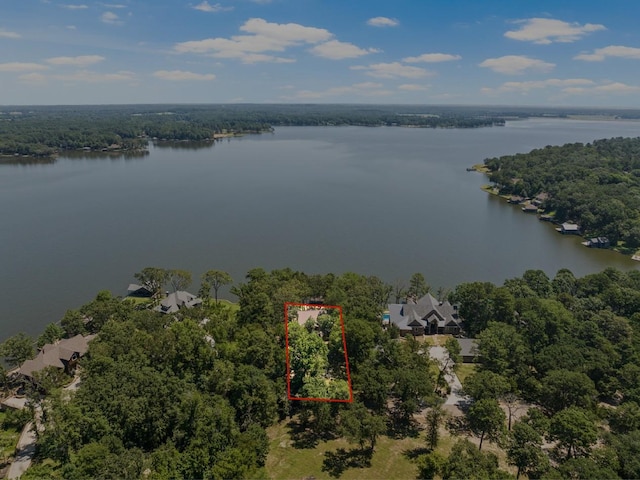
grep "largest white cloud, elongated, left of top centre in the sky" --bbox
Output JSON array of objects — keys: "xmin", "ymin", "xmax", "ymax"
[{"xmin": 173, "ymin": 18, "xmax": 333, "ymax": 63}]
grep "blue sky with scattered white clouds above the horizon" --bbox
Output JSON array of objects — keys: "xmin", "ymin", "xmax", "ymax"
[{"xmin": 0, "ymin": 0, "xmax": 640, "ymax": 108}]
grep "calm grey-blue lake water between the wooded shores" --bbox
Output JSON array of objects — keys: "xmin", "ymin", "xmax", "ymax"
[{"xmin": 0, "ymin": 119, "xmax": 640, "ymax": 339}]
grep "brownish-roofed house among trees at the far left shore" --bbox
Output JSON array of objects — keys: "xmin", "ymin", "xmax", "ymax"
[{"xmin": 18, "ymin": 334, "xmax": 95, "ymax": 379}]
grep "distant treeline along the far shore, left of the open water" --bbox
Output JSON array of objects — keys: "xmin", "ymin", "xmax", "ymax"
[{"xmin": 0, "ymin": 105, "xmax": 504, "ymax": 157}]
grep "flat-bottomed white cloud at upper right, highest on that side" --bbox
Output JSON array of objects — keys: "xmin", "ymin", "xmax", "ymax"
[{"xmin": 504, "ymin": 18, "xmax": 606, "ymax": 45}]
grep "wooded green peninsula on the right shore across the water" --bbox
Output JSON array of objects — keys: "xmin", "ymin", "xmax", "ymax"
[{"xmin": 484, "ymin": 137, "xmax": 640, "ymax": 253}]
